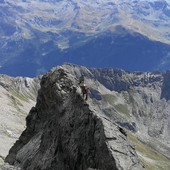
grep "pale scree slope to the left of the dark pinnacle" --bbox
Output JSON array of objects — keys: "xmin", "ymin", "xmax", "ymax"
[{"xmin": 0, "ymin": 74, "xmax": 41, "ymax": 164}]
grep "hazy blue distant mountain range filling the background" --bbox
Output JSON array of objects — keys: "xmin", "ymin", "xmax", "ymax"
[{"xmin": 0, "ymin": 0, "xmax": 170, "ymax": 77}]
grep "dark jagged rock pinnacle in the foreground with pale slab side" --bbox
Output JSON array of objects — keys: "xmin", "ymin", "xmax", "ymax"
[{"xmin": 5, "ymin": 67, "xmax": 144, "ymax": 170}]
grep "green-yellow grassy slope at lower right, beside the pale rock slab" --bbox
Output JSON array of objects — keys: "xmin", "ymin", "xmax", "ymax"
[{"xmin": 128, "ymin": 133, "xmax": 170, "ymax": 170}]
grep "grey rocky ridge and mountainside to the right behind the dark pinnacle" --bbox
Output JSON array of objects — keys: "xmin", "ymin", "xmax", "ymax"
[{"xmin": 60, "ymin": 64, "xmax": 170, "ymax": 170}]
